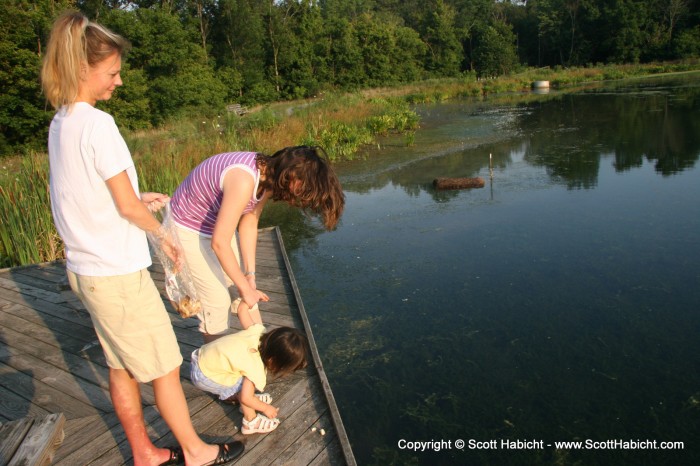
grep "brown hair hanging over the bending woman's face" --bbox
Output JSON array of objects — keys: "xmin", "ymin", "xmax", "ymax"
[{"xmin": 256, "ymin": 146, "xmax": 345, "ymax": 230}]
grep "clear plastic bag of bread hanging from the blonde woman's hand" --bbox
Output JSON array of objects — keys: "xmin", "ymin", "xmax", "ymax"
[{"xmin": 146, "ymin": 203, "xmax": 202, "ymax": 318}]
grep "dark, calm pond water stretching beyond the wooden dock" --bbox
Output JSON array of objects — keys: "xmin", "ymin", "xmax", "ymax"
[{"xmin": 262, "ymin": 74, "xmax": 700, "ymax": 465}]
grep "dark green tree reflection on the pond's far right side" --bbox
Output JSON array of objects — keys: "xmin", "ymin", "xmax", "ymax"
[{"xmin": 517, "ymin": 88, "xmax": 700, "ymax": 181}]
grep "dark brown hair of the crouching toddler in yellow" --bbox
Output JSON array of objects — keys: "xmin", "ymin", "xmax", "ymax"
[{"xmin": 258, "ymin": 327, "xmax": 309, "ymax": 376}]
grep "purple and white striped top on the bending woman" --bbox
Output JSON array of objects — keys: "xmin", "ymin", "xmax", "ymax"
[{"xmin": 170, "ymin": 152, "xmax": 260, "ymax": 236}]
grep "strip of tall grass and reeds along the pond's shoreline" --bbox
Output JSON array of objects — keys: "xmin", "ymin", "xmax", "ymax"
[{"xmin": 0, "ymin": 60, "xmax": 700, "ymax": 267}]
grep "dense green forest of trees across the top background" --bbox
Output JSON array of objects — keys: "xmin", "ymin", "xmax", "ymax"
[{"xmin": 0, "ymin": 0, "xmax": 700, "ymax": 155}]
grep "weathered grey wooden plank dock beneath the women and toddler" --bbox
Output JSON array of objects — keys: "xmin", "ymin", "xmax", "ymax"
[{"xmin": 0, "ymin": 228, "xmax": 356, "ymax": 466}]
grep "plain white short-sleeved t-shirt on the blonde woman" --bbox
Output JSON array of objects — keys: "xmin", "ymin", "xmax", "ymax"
[{"xmin": 49, "ymin": 102, "xmax": 151, "ymax": 276}]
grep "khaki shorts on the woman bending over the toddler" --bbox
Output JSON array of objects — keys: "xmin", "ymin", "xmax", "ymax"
[{"xmin": 177, "ymin": 227, "xmax": 257, "ymax": 335}]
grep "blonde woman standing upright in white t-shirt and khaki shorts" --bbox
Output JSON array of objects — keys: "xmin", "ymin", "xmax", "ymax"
[{"xmin": 41, "ymin": 12, "xmax": 243, "ymax": 466}]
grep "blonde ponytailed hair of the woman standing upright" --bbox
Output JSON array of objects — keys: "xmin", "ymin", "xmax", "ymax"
[{"xmin": 41, "ymin": 11, "xmax": 129, "ymax": 109}]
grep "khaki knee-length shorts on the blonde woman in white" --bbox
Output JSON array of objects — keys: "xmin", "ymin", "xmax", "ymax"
[{"xmin": 68, "ymin": 269, "xmax": 182, "ymax": 383}]
